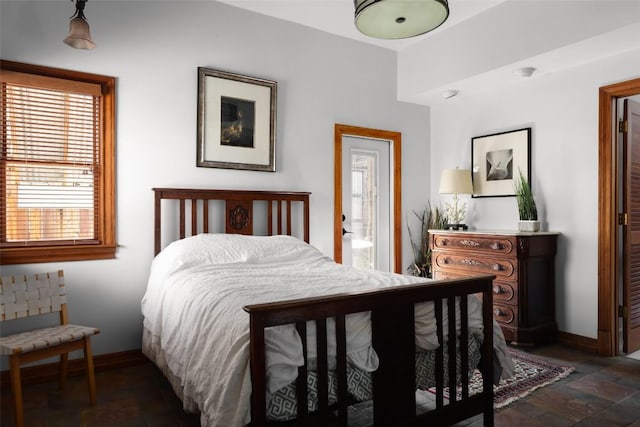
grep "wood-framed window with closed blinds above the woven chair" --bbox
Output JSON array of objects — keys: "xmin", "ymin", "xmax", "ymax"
[{"xmin": 0, "ymin": 61, "xmax": 116, "ymax": 264}]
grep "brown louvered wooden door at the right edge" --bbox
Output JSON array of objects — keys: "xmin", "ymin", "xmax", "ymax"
[{"xmin": 621, "ymin": 99, "xmax": 640, "ymax": 353}]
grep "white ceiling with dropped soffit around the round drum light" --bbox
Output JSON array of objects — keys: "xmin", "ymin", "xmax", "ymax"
[{"xmin": 217, "ymin": 0, "xmax": 640, "ymax": 105}]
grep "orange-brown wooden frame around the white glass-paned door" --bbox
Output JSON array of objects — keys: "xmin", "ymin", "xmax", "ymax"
[{"xmin": 333, "ymin": 123, "xmax": 402, "ymax": 273}]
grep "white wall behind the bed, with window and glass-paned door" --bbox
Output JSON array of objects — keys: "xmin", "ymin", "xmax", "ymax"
[{"xmin": 0, "ymin": 0, "xmax": 430, "ymax": 366}]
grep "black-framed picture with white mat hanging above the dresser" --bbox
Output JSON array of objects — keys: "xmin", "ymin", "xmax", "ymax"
[{"xmin": 471, "ymin": 128, "xmax": 531, "ymax": 197}]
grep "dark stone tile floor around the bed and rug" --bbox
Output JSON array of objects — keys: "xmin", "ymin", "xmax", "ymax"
[{"xmin": 0, "ymin": 345, "xmax": 640, "ymax": 427}]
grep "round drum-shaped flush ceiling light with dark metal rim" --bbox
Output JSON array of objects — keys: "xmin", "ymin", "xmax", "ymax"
[{"xmin": 353, "ymin": 0, "xmax": 449, "ymax": 39}]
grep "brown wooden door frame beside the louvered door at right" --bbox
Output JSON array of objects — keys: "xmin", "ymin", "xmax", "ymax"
[{"xmin": 597, "ymin": 78, "xmax": 640, "ymax": 356}]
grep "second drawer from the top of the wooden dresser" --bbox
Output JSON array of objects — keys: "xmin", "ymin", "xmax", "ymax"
[{"xmin": 432, "ymin": 251, "xmax": 517, "ymax": 280}]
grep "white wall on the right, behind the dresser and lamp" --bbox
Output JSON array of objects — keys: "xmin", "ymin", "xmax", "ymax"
[{"xmin": 431, "ymin": 50, "xmax": 640, "ymax": 339}]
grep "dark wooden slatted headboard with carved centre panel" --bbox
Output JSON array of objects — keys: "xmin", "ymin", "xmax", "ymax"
[{"xmin": 153, "ymin": 188, "xmax": 311, "ymax": 255}]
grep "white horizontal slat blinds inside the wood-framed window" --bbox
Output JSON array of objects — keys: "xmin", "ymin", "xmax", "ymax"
[{"xmin": 0, "ymin": 72, "xmax": 101, "ymax": 246}]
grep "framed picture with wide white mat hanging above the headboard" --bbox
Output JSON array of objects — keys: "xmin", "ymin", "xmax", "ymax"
[{"xmin": 197, "ymin": 67, "xmax": 277, "ymax": 172}]
